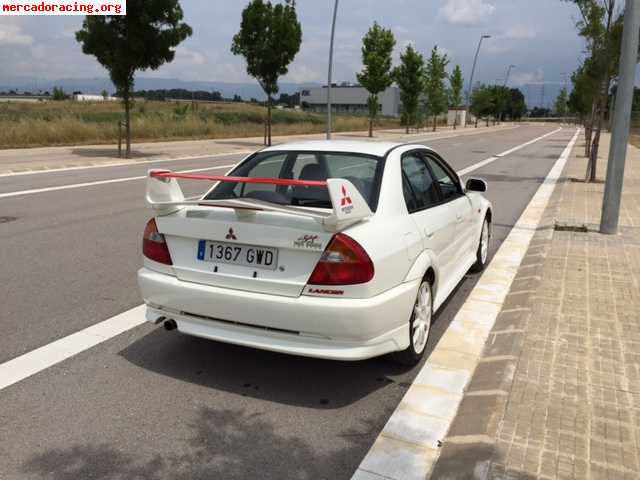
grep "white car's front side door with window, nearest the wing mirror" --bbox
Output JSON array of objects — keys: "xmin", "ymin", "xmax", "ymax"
[{"xmin": 424, "ymin": 152, "xmax": 476, "ymax": 262}]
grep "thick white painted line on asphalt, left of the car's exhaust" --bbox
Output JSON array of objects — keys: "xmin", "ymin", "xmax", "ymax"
[{"xmin": 0, "ymin": 305, "xmax": 145, "ymax": 390}]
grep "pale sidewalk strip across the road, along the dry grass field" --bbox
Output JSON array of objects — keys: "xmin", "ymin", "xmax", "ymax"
[{"xmin": 0, "ymin": 123, "xmax": 513, "ymax": 175}]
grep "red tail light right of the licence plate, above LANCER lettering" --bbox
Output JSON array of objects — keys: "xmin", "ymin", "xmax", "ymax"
[{"xmin": 308, "ymin": 233, "xmax": 374, "ymax": 285}]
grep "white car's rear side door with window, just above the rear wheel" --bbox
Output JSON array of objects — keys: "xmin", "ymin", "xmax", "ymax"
[{"xmin": 402, "ymin": 150, "xmax": 456, "ymax": 281}]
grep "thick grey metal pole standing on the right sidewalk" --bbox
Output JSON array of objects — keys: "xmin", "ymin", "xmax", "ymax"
[{"xmin": 600, "ymin": 0, "xmax": 640, "ymax": 235}]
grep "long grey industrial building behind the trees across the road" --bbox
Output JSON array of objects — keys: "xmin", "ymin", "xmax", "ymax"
[{"xmin": 300, "ymin": 82, "xmax": 402, "ymax": 117}]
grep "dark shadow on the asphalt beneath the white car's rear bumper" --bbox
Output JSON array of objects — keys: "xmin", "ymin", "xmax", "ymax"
[{"xmin": 120, "ymin": 328, "xmax": 418, "ymax": 409}]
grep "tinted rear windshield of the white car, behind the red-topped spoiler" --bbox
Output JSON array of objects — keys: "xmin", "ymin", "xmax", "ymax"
[{"xmin": 205, "ymin": 152, "xmax": 384, "ymax": 211}]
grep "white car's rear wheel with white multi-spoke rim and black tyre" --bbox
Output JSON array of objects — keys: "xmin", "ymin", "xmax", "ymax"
[{"xmin": 392, "ymin": 279, "xmax": 433, "ymax": 366}]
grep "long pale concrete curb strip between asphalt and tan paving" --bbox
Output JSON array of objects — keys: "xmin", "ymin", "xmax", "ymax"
[{"xmin": 352, "ymin": 130, "xmax": 580, "ymax": 480}]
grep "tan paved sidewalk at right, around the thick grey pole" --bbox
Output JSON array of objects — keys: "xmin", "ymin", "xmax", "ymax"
[{"xmin": 430, "ymin": 132, "xmax": 640, "ymax": 480}]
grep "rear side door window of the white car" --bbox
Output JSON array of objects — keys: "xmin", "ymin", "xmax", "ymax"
[{"xmin": 402, "ymin": 153, "xmax": 439, "ymax": 213}]
